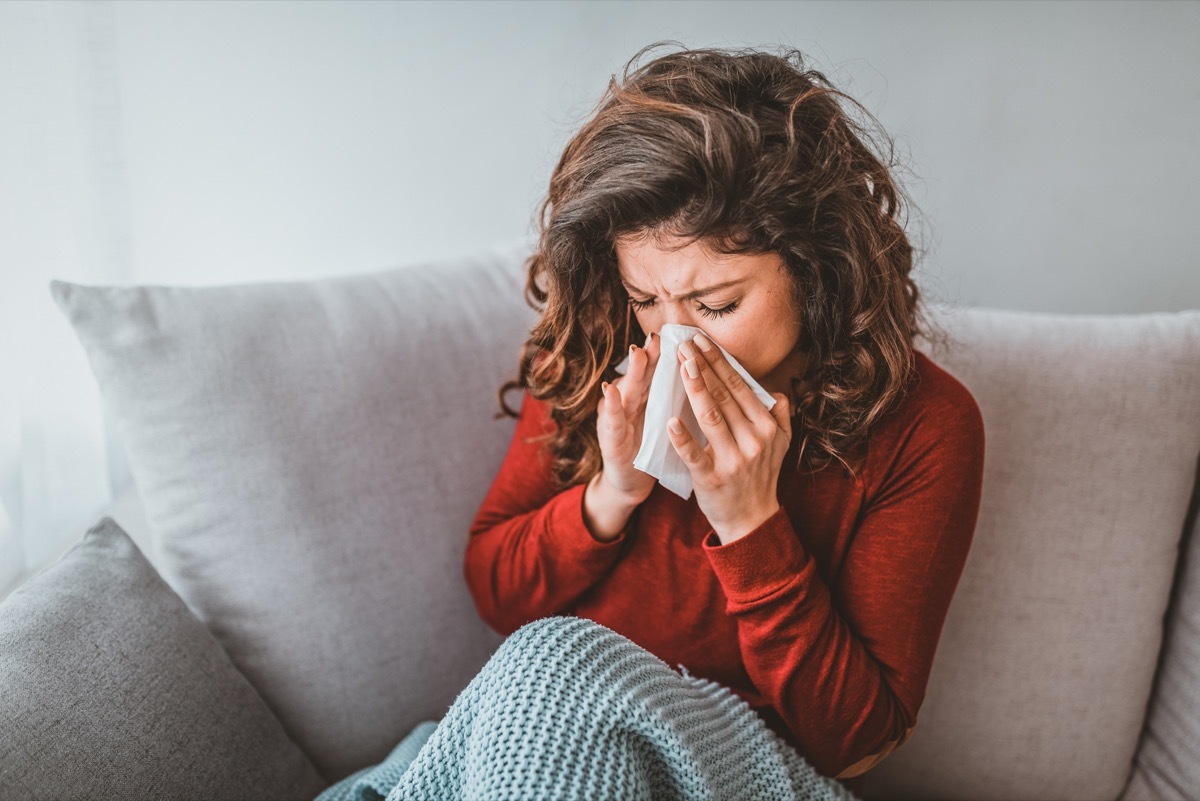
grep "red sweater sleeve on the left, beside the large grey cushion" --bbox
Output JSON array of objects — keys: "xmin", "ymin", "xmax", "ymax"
[{"xmin": 463, "ymin": 393, "xmax": 628, "ymax": 636}]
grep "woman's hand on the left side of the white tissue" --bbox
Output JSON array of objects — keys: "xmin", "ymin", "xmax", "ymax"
[{"xmin": 596, "ymin": 333, "xmax": 662, "ymax": 506}]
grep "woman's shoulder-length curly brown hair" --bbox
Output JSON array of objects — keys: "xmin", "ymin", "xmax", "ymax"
[{"xmin": 499, "ymin": 42, "xmax": 940, "ymax": 487}]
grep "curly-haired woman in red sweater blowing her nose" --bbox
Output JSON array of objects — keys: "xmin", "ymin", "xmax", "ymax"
[{"xmin": 464, "ymin": 38, "xmax": 984, "ymax": 789}]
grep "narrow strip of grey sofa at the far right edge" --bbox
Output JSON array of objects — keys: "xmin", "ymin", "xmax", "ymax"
[{"xmin": 1121, "ymin": 474, "xmax": 1200, "ymax": 801}]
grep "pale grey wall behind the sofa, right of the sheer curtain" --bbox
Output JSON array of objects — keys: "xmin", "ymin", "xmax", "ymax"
[{"xmin": 105, "ymin": 0, "xmax": 1200, "ymax": 312}]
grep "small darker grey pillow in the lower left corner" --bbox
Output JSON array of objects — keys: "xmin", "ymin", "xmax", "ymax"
[{"xmin": 0, "ymin": 517, "xmax": 326, "ymax": 801}]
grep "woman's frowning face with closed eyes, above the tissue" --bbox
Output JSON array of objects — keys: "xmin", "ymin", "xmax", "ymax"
[{"xmin": 616, "ymin": 230, "xmax": 804, "ymax": 393}]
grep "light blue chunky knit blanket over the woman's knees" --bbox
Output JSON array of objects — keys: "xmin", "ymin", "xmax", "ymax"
[{"xmin": 317, "ymin": 616, "xmax": 859, "ymax": 801}]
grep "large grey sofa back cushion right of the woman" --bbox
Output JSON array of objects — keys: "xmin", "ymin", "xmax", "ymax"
[{"xmin": 863, "ymin": 309, "xmax": 1200, "ymax": 799}]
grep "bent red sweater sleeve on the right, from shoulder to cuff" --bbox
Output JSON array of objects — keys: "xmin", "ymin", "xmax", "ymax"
[{"xmin": 703, "ymin": 383, "xmax": 984, "ymax": 778}]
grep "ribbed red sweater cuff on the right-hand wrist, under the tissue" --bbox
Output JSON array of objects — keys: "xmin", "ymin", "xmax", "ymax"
[{"xmin": 701, "ymin": 506, "xmax": 812, "ymax": 603}]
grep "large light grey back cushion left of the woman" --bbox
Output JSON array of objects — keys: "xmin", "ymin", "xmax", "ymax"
[{"xmin": 52, "ymin": 241, "xmax": 534, "ymax": 781}]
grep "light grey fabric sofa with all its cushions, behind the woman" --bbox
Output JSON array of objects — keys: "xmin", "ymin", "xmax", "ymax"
[{"xmin": 0, "ymin": 240, "xmax": 1200, "ymax": 801}]
